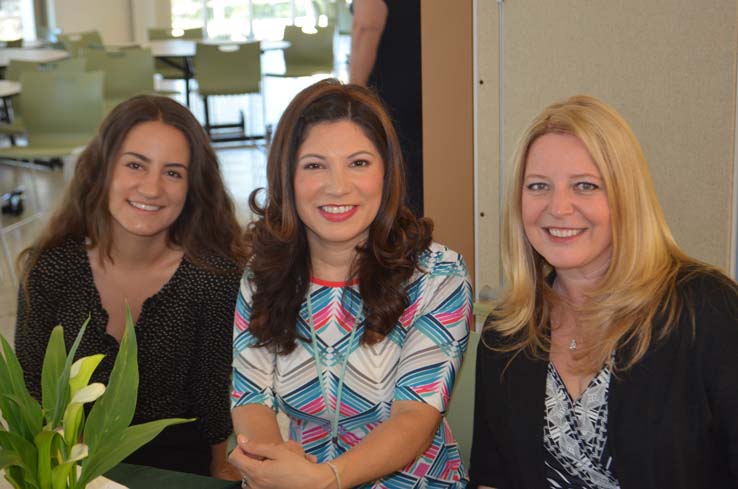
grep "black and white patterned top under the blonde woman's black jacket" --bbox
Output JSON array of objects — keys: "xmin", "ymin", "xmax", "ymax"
[{"xmin": 543, "ymin": 362, "xmax": 620, "ymax": 489}]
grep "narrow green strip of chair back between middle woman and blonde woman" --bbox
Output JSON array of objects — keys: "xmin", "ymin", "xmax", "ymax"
[{"xmin": 446, "ymin": 331, "xmax": 479, "ymax": 469}]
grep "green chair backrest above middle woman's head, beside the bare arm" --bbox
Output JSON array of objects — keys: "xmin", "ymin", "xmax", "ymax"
[{"xmin": 282, "ymin": 25, "xmax": 335, "ymax": 74}]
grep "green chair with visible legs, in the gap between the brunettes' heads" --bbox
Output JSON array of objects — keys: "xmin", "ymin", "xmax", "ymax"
[{"xmin": 195, "ymin": 42, "xmax": 266, "ymax": 141}]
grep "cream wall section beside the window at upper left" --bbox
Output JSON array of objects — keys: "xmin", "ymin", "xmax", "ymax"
[{"xmin": 50, "ymin": 0, "xmax": 133, "ymax": 44}]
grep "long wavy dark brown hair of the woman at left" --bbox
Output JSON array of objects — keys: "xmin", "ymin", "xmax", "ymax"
[{"xmin": 18, "ymin": 95, "xmax": 246, "ymax": 288}]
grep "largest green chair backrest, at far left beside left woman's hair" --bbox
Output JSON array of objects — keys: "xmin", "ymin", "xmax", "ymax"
[{"xmin": 20, "ymin": 71, "xmax": 104, "ymax": 148}]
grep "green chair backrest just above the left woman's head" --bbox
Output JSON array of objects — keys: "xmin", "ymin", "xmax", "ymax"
[{"xmin": 85, "ymin": 48, "xmax": 154, "ymax": 103}]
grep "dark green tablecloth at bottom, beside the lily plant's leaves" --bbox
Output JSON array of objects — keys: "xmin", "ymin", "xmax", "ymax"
[{"xmin": 105, "ymin": 464, "xmax": 241, "ymax": 489}]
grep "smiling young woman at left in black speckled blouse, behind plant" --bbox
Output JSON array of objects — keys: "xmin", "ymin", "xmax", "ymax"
[{"xmin": 15, "ymin": 96, "xmax": 245, "ymax": 479}]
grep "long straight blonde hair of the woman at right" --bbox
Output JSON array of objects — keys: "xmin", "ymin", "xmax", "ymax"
[{"xmin": 487, "ymin": 95, "xmax": 708, "ymax": 372}]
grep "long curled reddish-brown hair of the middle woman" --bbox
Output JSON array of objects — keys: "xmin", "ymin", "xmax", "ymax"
[{"xmin": 246, "ymin": 80, "xmax": 433, "ymax": 354}]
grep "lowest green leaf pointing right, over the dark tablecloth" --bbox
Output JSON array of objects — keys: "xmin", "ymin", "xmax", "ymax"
[{"xmin": 77, "ymin": 418, "xmax": 194, "ymax": 488}]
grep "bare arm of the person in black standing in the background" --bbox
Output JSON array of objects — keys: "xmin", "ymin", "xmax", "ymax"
[{"xmin": 349, "ymin": 0, "xmax": 387, "ymax": 85}]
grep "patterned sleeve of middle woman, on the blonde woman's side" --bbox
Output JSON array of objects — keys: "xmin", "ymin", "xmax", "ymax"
[{"xmin": 394, "ymin": 244, "xmax": 472, "ymax": 413}]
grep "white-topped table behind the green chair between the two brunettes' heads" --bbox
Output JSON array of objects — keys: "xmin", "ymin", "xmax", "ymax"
[{"xmin": 143, "ymin": 39, "xmax": 290, "ymax": 107}]
